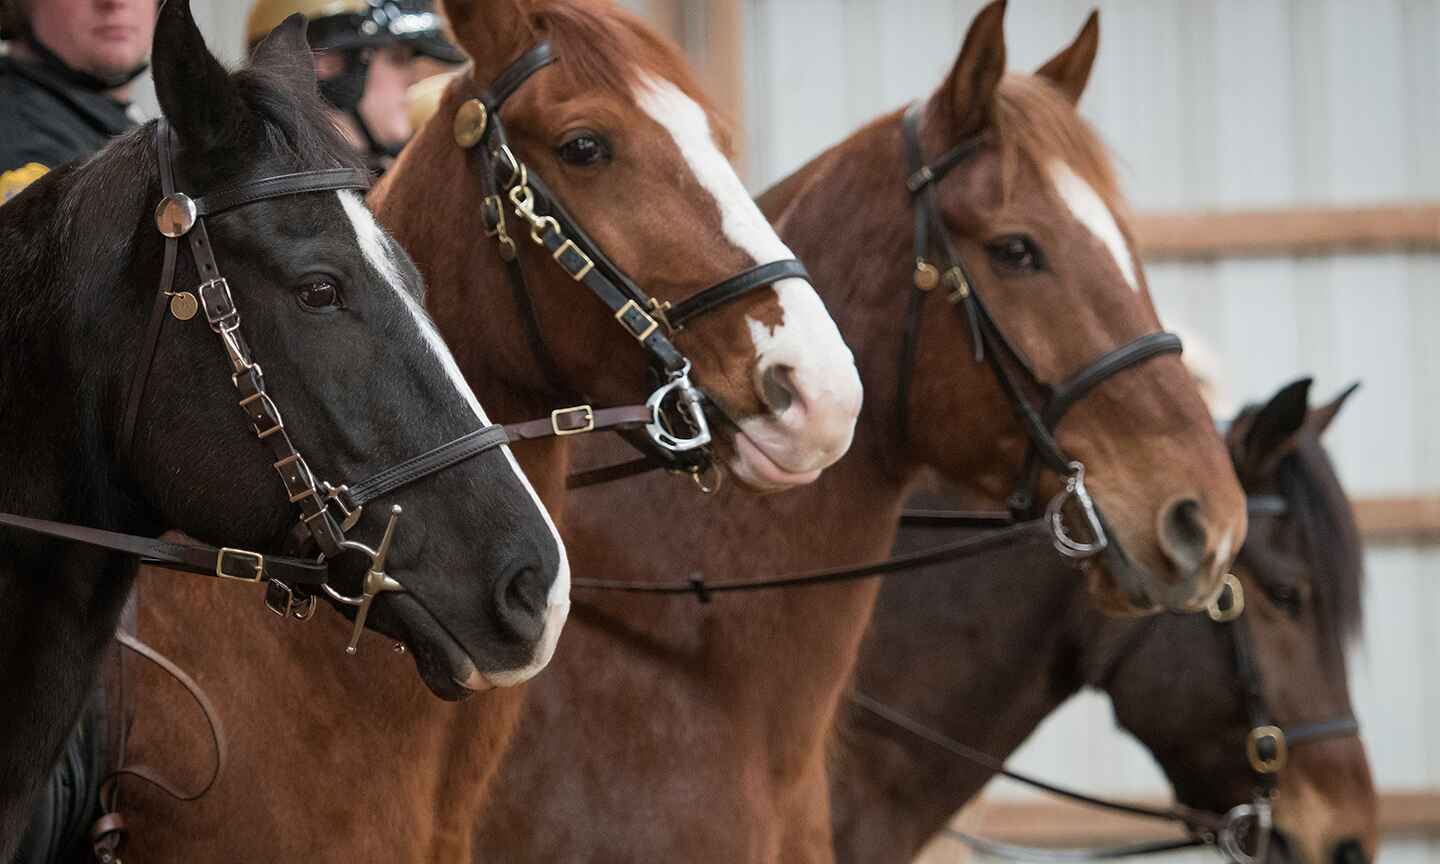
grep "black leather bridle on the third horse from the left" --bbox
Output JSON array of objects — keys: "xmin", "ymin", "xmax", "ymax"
[{"xmin": 899, "ymin": 102, "xmax": 1181, "ymax": 560}]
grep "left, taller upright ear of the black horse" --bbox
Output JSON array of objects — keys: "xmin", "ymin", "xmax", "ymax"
[{"xmin": 151, "ymin": 0, "xmax": 245, "ymax": 150}]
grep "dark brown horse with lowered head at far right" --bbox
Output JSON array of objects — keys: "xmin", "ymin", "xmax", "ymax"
[{"xmin": 831, "ymin": 382, "xmax": 1377, "ymax": 864}]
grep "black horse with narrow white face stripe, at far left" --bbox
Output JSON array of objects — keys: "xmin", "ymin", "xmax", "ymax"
[{"xmin": 0, "ymin": 0, "xmax": 563, "ymax": 861}]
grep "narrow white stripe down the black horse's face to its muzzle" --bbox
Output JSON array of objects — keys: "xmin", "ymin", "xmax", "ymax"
[{"xmin": 337, "ymin": 190, "xmax": 570, "ymax": 673}]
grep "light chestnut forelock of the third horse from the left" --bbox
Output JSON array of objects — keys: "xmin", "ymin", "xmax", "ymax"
[{"xmin": 992, "ymin": 72, "xmax": 1129, "ymax": 221}]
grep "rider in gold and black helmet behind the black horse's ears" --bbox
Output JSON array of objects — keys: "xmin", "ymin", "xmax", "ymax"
[{"xmin": 245, "ymin": 0, "xmax": 465, "ymax": 170}]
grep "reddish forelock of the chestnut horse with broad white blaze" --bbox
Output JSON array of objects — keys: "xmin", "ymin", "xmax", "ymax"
[{"xmin": 527, "ymin": 0, "xmax": 732, "ymax": 154}]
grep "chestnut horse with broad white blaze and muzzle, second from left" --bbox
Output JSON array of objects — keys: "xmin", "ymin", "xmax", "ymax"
[{"xmin": 112, "ymin": 0, "xmax": 860, "ymax": 861}]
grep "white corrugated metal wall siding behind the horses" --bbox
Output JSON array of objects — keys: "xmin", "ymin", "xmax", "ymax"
[{"xmin": 746, "ymin": 0, "xmax": 1440, "ymax": 861}]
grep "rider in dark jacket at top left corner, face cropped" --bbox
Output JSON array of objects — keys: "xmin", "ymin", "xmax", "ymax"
[{"xmin": 0, "ymin": 0, "xmax": 156, "ymax": 203}]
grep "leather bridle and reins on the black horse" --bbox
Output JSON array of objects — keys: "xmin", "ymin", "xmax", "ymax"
[{"xmin": 0, "ymin": 120, "xmax": 507, "ymax": 654}]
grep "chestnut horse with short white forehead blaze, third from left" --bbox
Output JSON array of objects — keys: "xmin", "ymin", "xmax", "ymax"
[{"xmin": 474, "ymin": 6, "xmax": 1244, "ymax": 863}]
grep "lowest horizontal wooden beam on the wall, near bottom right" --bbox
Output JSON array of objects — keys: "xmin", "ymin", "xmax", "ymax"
[{"xmin": 953, "ymin": 789, "xmax": 1440, "ymax": 845}]
